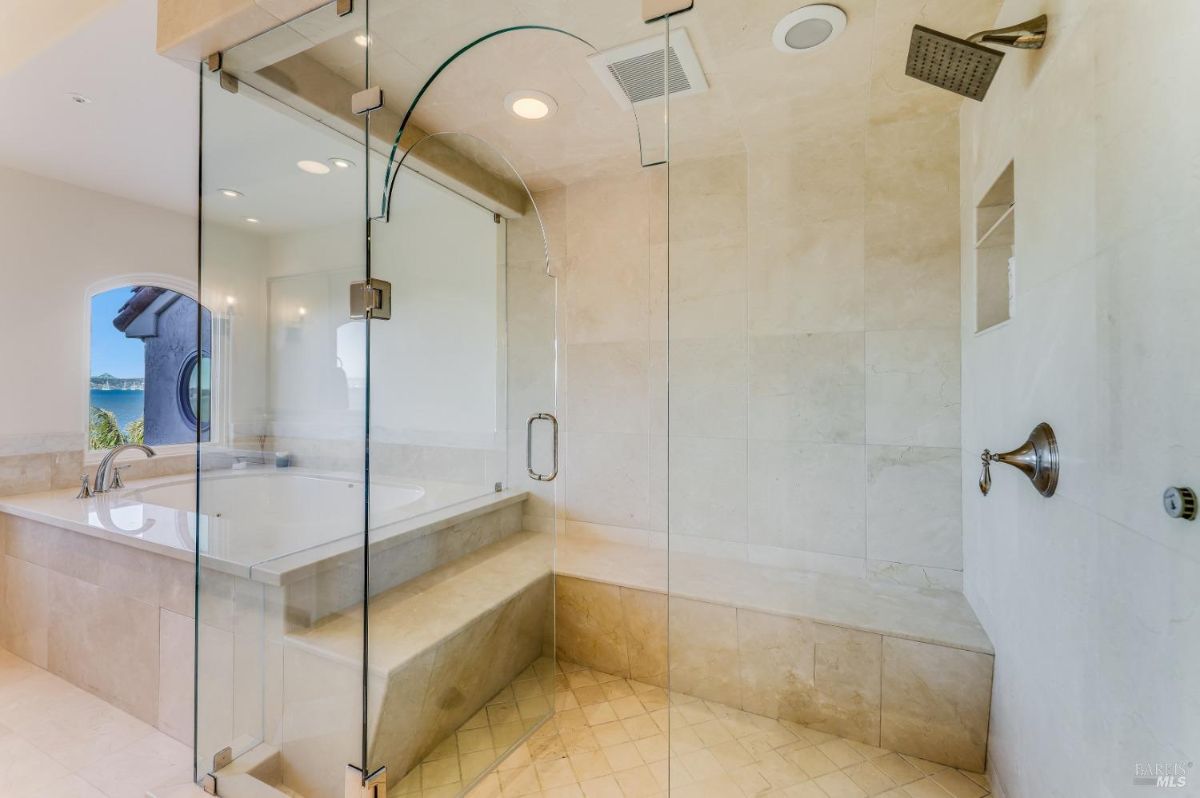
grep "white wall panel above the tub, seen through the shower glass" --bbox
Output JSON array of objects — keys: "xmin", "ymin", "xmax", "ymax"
[{"xmin": 258, "ymin": 166, "xmax": 504, "ymax": 472}]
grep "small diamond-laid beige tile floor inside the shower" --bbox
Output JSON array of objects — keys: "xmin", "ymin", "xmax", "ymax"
[{"xmin": 398, "ymin": 660, "xmax": 990, "ymax": 798}]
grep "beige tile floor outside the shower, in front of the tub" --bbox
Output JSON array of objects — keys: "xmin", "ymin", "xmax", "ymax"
[{"xmin": 0, "ymin": 649, "xmax": 192, "ymax": 798}]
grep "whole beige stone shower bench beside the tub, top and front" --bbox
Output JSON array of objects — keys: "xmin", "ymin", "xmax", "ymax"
[{"xmin": 281, "ymin": 532, "xmax": 553, "ymax": 796}]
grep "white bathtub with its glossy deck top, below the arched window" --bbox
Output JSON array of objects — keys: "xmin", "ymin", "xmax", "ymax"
[{"xmin": 0, "ymin": 467, "xmax": 501, "ymax": 581}]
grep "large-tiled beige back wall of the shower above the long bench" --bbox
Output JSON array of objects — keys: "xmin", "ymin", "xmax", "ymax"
[{"xmin": 520, "ymin": 89, "xmax": 962, "ymax": 588}]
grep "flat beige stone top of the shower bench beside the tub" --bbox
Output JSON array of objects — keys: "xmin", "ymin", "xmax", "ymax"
[{"xmin": 284, "ymin": 532, "xmax": 553, "ymax": 677}]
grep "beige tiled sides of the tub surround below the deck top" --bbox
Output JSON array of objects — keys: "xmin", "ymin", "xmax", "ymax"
[{"xmin": 0, "ymin": 476, "xmax": 535, "ymax": 768}]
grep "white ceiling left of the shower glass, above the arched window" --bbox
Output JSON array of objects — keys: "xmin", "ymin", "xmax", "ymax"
[{"xmin": 0, "ymin": 0, "xmax": 198, "ymax": 214}]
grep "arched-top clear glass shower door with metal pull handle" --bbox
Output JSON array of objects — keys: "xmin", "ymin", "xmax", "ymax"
[{"xmin": 366, "ymin": 126, "xmax": 557, "ymax": 790}]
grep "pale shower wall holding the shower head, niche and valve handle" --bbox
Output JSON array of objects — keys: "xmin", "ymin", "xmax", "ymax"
[{"xmin": 961, "ymin": 0, "xmax": 1200, "ymax": 798}]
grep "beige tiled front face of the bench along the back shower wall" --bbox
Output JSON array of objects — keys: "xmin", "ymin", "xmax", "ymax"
[{"xmin": 556, "ymin": 576, "xmax": 992, "ymax": 770}]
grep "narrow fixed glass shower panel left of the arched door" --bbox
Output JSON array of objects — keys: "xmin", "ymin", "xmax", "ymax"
[{"xmin": 194, "ymin": 5, "xmax": 367, "ymax": 798}]
